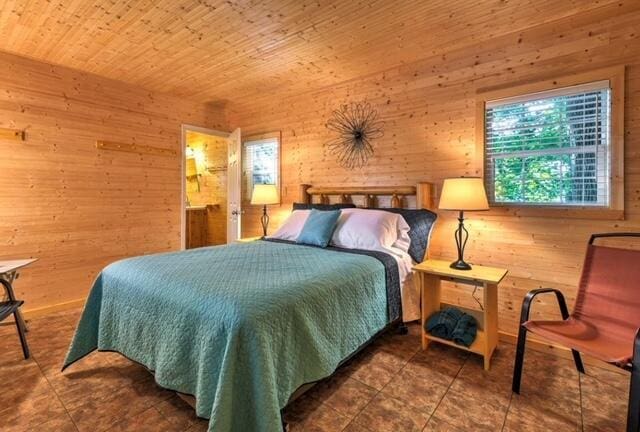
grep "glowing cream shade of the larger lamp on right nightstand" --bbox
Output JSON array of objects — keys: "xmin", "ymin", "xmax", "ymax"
[{"xmin": 438, "ymin": 177, "xmax": 489, "ymax": 211}]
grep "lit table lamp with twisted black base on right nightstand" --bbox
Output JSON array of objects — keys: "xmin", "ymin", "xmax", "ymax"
[{"xmin": 438, "ymin": 177, "xmax": 489, "ymax": 270}]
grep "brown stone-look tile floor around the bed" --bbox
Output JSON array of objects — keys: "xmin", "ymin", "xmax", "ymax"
[{"xmin": 0, "ymin": 310, "xmax": 628, "ymax": 432}]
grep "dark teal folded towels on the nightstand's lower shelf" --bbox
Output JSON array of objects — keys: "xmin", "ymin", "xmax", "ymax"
[{"xmin": 425, "ymin": 307, "xmax": 478, "ymax": 347}]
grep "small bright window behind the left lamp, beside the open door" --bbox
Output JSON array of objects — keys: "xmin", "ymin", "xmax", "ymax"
[{"xmin": 242, "ymin": 133, "xmax": 280, "ymax": 199}]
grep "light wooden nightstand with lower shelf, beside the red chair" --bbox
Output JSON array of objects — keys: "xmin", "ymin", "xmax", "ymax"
[{"xmin": 413, "ymin": 259, "xmax": 507, "ymax": 370}]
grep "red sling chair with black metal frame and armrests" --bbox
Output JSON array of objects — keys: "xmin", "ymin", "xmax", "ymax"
[{"xmin": 512, "ymin": 233, "xmax": 640, "ymax": 432}]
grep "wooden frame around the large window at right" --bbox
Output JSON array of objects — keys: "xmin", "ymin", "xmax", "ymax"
[{"xmin": 476, "ymin": 66, "xmax": 625, "ymax": 220}]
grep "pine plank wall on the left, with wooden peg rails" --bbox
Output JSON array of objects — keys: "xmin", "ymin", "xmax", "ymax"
[{"xmin": 0, "ymin": 53, "xmax": 226, "ymax": 310}]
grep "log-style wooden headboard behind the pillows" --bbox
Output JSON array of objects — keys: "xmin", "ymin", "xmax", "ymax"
[{"xmin": 300, "ymin": 183, "xmax": 434, "ymax": 210}]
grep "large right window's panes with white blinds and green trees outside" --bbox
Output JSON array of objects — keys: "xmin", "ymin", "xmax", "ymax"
[{"xmin": 485, "ymin": 88, "xmax": 610, "ymax": 206}]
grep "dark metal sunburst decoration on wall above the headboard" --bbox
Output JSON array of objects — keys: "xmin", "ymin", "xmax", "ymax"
[{"xmin": 327, "ymin": 102, "xmax": 384, "ymax": 169}]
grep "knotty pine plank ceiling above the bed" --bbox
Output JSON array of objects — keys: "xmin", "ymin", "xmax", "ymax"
[{"xmin": 0, "ymin": 0, "xmax": 615, "ymax": 103}]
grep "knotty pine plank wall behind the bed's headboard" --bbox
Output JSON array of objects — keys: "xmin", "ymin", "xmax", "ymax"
[{"xmin": 228, "ymin": 2, "xmax": 640, "ymax": 333}]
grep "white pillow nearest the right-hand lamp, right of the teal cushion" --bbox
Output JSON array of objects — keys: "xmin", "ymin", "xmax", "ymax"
[{"xmin": 331, "ymin": 209, "xmax": 411, "ymax": 252}]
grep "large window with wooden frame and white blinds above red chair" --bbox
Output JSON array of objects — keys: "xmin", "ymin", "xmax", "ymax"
[{"xmin": 480, "ymin": 67, "xmax": 624, "ymax": 219}]
